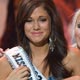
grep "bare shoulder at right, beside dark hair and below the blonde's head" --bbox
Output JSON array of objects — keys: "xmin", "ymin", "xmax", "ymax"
[{"xmin": 63, "ymin": 47, "xmax": 80, "ymax": 75}]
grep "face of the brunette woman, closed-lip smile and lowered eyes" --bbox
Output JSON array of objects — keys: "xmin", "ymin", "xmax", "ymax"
[{"xmin": 24, "ymin": 7, "xmax": 51, "ymax": 44}]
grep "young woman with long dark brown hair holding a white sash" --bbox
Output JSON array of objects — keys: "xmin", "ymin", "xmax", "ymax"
[{"xmin": 0, "ymin": 0, "xmax": 80, "ymax": 80}]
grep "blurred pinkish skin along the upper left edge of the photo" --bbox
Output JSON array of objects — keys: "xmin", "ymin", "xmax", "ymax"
[{"xmin": 0, "ymin": 0, "xmax": 9, "ymax": 40}]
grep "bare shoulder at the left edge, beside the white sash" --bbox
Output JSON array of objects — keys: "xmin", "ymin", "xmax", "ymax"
[{"xmin": 0, "ymin": 56, "xmax": 12, "ymax": 80}]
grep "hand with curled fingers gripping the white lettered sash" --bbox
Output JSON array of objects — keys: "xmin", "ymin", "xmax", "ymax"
[{"xmin": 6, "ymin": 66, "xmax": 30, "ymax": 80}]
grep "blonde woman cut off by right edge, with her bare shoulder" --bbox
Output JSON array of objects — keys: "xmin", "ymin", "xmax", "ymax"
[{"xmin": 64, "ymin": 10, "xmax": 80, "ymax": 75}]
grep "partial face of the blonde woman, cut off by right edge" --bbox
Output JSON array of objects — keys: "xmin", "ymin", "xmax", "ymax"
[{"xmin": 75, "ymin": 15, "xmax": 80, "ymax": 48}]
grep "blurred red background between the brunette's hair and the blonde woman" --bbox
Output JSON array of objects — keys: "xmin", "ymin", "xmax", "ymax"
[{"xmin": 53, "ymin": 0, "xmax": 80, "ymax": 44}]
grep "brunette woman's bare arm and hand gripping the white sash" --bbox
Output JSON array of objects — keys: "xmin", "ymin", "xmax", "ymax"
[{"xmin": 0, "ymin": 56, "xmax": 30, "ymax": 80}]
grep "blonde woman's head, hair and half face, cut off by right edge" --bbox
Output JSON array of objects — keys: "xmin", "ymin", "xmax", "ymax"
[{"xmin": 71, "ymin": 9, "xmax": 80, "ymax": 50}]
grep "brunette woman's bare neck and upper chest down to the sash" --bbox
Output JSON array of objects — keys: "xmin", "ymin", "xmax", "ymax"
[{"xmin": 30, "ymin": 43, "xmax": 49, "ymax": 78}]
